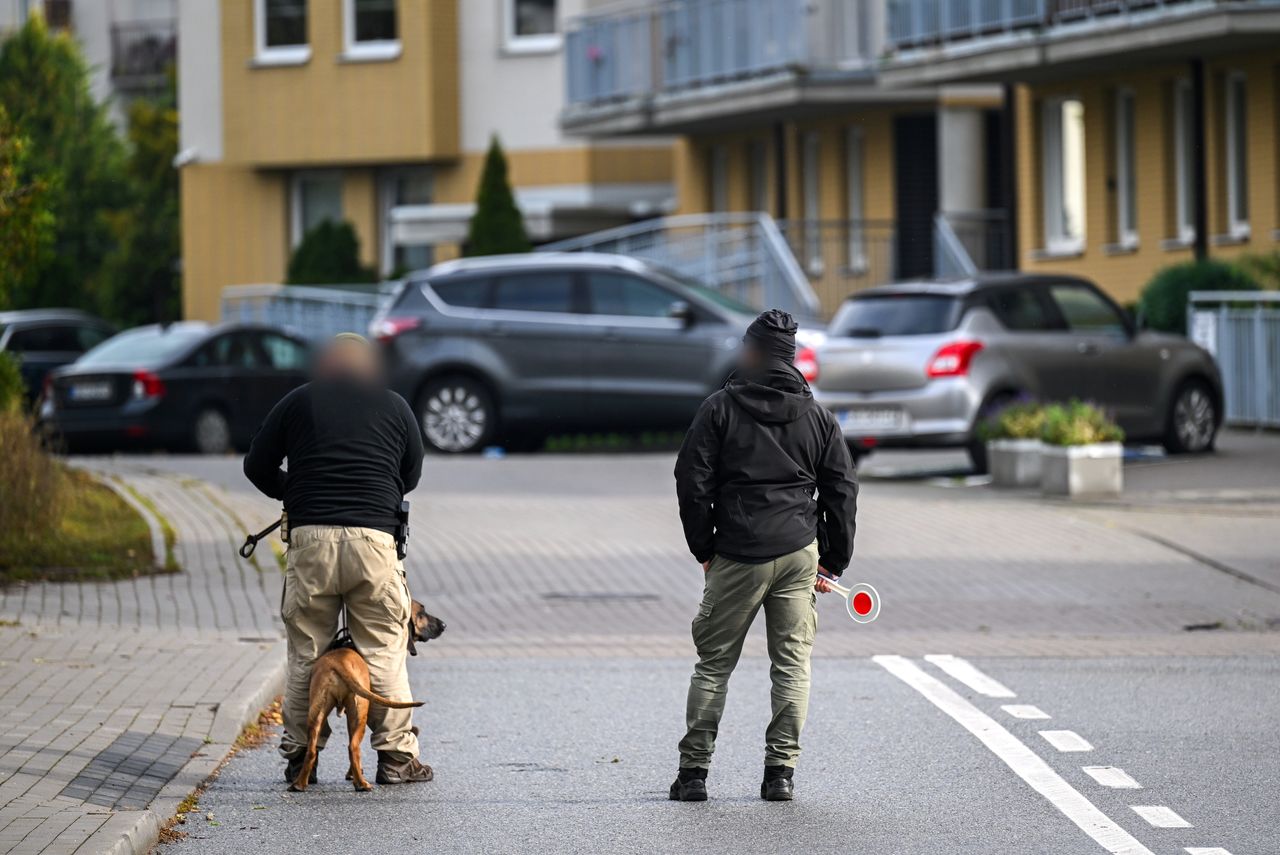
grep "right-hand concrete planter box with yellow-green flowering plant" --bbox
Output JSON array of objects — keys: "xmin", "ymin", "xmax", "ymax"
[{"xmin": 1041, "ymin": 401, "xmax": 1124, "ymax": 495}]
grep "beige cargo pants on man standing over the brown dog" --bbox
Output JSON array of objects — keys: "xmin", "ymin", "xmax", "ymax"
[{"xmin": 280, "ymin": 526, "xmax": 417, "ymax": 759}]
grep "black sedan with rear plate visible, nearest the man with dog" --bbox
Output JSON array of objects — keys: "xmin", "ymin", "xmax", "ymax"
[{"xmin": 41, "ymin": 323, "xmax": 310, "ymax": 454}]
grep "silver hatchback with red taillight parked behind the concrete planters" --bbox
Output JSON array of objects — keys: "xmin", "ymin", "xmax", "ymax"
[{"xmin": 814, "ymin": 274, "xmax": 1222, "ymax": 471}]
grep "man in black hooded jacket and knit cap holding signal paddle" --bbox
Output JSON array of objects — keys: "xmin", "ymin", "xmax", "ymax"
[{"xmin": 671, "ymin": 308, "xmax": 858, "ymax": 801}]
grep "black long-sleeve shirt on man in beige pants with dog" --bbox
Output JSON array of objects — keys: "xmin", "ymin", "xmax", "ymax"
[{"xmin": 244, "ymin": 379, "xmax": 422, "ymax": 534}]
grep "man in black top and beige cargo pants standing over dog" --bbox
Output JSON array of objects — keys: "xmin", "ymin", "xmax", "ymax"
[{"xmin": 244, "ymin": 333, "xmax": 433, "ymax": 783}]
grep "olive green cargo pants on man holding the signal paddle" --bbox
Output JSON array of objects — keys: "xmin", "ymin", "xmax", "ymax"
[{"xmin": 680, "ymin": 543, "xmax": 818, "ymax": 769}]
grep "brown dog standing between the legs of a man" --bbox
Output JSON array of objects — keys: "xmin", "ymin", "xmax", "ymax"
[{"xmin": 289, "ymin": 600, "xmax": 444, "ymax": 792}]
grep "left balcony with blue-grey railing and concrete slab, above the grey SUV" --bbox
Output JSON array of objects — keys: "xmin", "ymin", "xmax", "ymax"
[{"xmin": 561, "ymin": 0, "xmax": 883, "ymax": 134}]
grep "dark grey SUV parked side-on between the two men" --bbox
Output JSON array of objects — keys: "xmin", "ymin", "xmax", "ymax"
[{"xmin": 370, "ymin": 252, "xmax": 755, "ymax": 453}]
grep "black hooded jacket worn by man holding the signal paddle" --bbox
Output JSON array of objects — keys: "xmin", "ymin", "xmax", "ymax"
[{"xmin": 676, "ymin": 362, "xmax": 858, "ymax": 576}]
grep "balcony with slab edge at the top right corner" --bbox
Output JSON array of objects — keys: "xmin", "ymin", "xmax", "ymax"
[{"xmin": 883, "ymin": 0, "xmax": 1280, "ymax": 86}]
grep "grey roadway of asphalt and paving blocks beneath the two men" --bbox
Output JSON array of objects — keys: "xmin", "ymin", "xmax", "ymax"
[{"xmin": 135, "ymin": 443, "xmax": 1280, "ymax": 855}]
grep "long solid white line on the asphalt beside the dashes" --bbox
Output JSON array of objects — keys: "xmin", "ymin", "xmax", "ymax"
[{"xmin": 872, "ymin": 657, "xmax": 1155, "ymax": 855}]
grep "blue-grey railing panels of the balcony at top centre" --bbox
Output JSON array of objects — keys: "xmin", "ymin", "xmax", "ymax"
[{"xmin": 566, "ymin": 0, "xmax": 881, "ymax": 109}]
